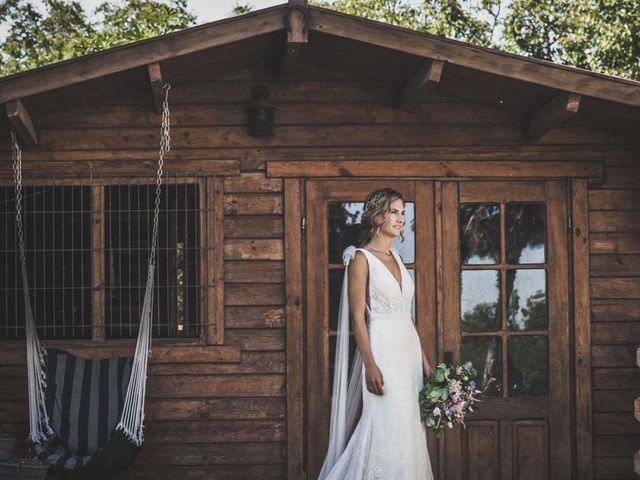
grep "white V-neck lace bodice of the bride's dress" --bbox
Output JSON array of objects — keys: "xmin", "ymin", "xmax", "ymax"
[{"xmin": 356, "ymin": 248, "xmax": 415, "ymax": 317}]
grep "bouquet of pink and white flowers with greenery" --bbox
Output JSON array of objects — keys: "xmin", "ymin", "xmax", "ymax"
[{"xmin": 419, "ymin": 362, "xmax": 481, "ymax": 437}]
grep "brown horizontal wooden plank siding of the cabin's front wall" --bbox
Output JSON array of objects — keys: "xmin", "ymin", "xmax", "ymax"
[{"xmin": 0, "ymin": 54, "xmax": 640, "ymax": 480}]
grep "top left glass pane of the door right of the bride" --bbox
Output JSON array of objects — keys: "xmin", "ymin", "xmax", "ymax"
[{"xmin": 460, "ymin": 204, "xmax": 500, "ymax": 265}]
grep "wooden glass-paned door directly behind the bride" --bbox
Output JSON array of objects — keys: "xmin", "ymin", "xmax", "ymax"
[{"xmin": 306, "ymin": 179, "xmax": 437, "ymax": 479}]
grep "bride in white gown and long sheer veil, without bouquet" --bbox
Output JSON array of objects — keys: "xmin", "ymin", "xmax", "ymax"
[{"xmin": 318, "ymin": 188, "xmax": 433, "ymax": 480}]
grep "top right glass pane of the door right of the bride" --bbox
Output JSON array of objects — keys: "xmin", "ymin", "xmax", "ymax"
[{"xmin": 505, "ymin": 203, "xmax": 544, "ymax": 264}]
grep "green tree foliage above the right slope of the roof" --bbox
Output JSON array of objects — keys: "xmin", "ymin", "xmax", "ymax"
[{"xmin": 311, "ymin": 0, "xmax": 640, "ymax": 80}]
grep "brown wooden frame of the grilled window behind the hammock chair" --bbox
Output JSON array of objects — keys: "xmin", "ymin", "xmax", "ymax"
[{"xmin": 0, "ymin": 175, "xmax": 224, "ymax": 349}]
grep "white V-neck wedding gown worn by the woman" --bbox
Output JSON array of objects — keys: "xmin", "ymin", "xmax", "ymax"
[{"xmin": 324, "ymin": 248, "xmax": 433, "ymax": 480}]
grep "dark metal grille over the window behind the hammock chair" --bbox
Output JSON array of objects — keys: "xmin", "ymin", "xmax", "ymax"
[{"xmin": 0, "ymin": 177, "xmax": 206, "ymax": 340}]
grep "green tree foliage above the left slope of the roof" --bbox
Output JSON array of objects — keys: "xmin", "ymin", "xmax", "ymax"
[{"xmin": 0, "ymin": 0, "xmax": 196, "ymax": 75}]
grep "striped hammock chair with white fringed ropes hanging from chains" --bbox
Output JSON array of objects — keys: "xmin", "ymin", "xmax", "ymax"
[{"xmin": 11, "ymin": 84, "xmax": 171, "ymax": 480}]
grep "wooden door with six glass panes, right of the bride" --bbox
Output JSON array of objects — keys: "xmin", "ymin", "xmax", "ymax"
[{"xmin": 439, "ymin": 181, "xmax": 571, "ymax": 480}]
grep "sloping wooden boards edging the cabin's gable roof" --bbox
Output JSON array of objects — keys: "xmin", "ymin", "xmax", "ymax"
[{"xmin": 0, "ymin": 4, "xmax": 640, "ymax": 107}]
